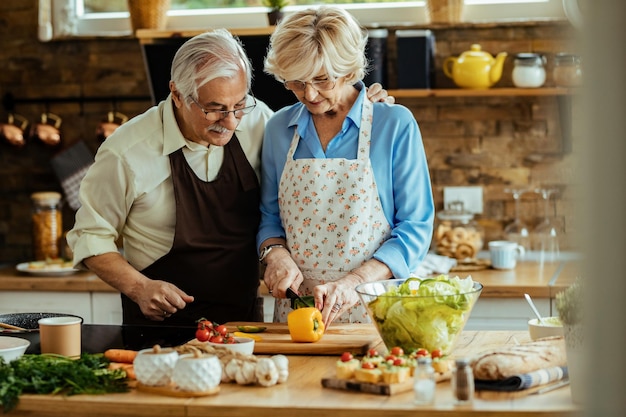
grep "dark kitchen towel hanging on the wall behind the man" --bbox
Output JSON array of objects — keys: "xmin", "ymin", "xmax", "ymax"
[{"xmin": 52, "ymin": 141, "xmax": 94, "ymax": 210}]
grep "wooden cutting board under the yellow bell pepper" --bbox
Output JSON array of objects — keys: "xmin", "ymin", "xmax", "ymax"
[{"xmin": 225, "ymin": 322, "xmax": 381, "ymax": 355}]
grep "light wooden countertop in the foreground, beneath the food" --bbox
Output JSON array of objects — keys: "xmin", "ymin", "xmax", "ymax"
[{"xmin": 8, "ymin": 331, "xmax": 577, "ymax": 417}]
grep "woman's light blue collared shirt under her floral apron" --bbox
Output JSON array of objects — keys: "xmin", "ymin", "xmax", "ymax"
[{"xmin": 257, "ymin": 84, "xmax": 434, "ymax": 278}]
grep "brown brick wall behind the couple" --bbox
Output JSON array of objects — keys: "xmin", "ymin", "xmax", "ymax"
[{"xmin": 0, "ymin": 0, "xmax": 576, "ymax": 263}]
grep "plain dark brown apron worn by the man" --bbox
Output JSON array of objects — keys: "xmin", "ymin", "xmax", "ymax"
[{"xmin": 122, "ymin": 136, "xmax": 262, "ymax": 326}]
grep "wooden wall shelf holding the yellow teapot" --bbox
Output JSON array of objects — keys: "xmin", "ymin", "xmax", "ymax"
[{"xmin": 388, "ymin": 87, "xmax": 572, "ymax": 98}]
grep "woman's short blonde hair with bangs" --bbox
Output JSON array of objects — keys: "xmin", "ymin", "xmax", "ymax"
[{"xmin": 264, "ymin": 6, "xmax": 368, "ymax": 84}]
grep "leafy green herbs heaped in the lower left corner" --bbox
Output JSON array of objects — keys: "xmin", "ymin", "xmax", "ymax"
[{"xmin": 0, "ymin": 354, "xmax": 129, "ymax": 413}]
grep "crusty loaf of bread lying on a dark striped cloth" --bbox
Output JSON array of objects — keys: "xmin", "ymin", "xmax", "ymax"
[{"xmin": 471, "ymin": 336, "xmax": 567, "ymax": 381}]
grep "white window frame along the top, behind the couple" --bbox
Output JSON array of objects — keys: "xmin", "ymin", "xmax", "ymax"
[{"xmin": 39, "ymin": 0, "xmax": 566, "ymax": 41}]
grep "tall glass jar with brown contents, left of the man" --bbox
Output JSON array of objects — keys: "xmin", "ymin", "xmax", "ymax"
[{"xmin": 31, "ymin": 191, "xmax": 63, "ymax": 261}]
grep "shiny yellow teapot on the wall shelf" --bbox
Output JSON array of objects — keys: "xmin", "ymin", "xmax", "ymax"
[{"xmin": 443, "ymin": 44, "xmax": 507, "ymax": 88}]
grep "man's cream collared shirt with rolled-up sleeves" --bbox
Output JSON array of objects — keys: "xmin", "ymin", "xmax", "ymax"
[{"xmin": 68, "ymin": 97, "xmax": 273, "ymax": 270}]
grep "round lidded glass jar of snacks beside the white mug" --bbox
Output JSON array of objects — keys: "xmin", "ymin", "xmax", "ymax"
[{"xmin": 434, "ymin": 201, "xmax": 484, "ymax": 260}]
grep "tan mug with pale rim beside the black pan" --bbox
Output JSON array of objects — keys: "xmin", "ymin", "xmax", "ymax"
[{"xmin": 38, "ymin": 316, "xmax": 82, "ymax": 358}]
